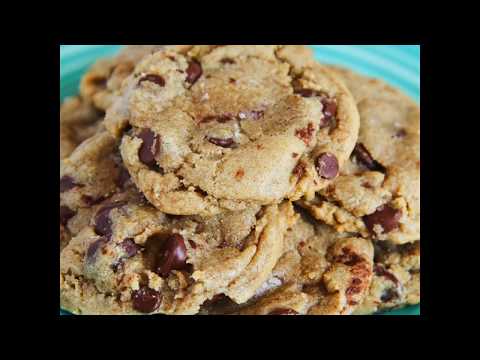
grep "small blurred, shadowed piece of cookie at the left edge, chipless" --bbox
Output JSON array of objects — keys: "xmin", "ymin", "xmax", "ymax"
[{"xmin": 60, "ymin": 97, "xmax": 103, "ymax": 159}]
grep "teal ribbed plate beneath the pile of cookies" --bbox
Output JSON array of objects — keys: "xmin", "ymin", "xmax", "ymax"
[{"xmin": 60, "ymin": 45, "xmax": 420, "ymax": 315}]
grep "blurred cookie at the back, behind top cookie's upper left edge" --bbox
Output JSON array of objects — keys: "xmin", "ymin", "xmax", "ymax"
[{"xmin": 80, "ymin": 45, "xmax": 190, "ymax": 111}]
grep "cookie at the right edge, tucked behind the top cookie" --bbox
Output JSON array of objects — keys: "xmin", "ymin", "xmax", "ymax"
[{"xmin": 300, "ymin": 68, "xmax": 420, "ymax": 244}]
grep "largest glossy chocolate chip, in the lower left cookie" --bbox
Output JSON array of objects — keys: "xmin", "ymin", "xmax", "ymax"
[{"xmin": 157, "ymin": 234, "xmax": 187, "ymax": 277}]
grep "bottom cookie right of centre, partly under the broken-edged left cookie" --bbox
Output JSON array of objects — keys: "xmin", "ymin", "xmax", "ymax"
[{"xmin": 202, "ymin": 211, "xmax": 373, "ymax": 315}]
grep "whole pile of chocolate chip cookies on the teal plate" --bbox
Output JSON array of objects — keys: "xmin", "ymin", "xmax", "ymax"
[{"xmin": 60, "ymin": 45, "xmax": 420, "ymax": 315}]
